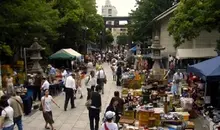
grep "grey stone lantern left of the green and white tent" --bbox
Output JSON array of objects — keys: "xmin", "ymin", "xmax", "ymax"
[{"xmin": 27, "ymin": 37, "xmax": 45, "ymax": 73}]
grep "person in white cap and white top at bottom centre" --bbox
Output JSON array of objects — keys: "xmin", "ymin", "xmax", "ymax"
[{"xmin": 101, "ymin": 111, "xmax": 118, "ymax": 130}]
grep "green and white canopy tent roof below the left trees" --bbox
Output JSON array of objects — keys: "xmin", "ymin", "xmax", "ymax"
[{"xmin": 49, "ymin": 48, "xmax": 82, "ymax": 60}]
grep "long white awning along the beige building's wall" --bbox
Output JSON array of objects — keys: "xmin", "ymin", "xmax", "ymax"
[{"xmin": 176, "ymin": 48, "xmax": 217, "ymax": 59}]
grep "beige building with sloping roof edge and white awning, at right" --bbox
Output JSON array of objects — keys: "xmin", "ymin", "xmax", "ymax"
[{"xmin": 152, "ymin": 4, "xmax": 219, "ymax": 59}]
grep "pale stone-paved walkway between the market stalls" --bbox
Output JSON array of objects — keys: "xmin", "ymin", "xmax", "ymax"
[{"xmin": 17, "ymin": 63, "xmax": 120, "ymax": 130}]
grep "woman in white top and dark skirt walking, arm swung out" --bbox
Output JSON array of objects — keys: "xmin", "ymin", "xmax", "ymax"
[{"xmin": 41, "ymin": 89, "xmax": 60, "ymax": 130}]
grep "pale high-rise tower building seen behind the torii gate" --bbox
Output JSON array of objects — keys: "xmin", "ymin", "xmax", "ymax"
[{"xmin": 102, "ymin": 0, "xmax": 127, "ymax": 45}]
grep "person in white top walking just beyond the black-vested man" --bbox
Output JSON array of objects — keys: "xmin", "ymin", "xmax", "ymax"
[{"xmin": 96, "ymin": 67, "xmax": 106, "ymax": 94}]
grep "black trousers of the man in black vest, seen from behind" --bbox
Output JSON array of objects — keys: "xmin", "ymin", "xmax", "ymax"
[{"xmin": 89, "ymin": 108, "xmax": 100, "ymax": 130}]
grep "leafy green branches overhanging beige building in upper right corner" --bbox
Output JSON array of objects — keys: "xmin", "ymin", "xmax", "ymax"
[{"xmin": 168, "ymin": 0, "xmax": 220, "ymax": 49}]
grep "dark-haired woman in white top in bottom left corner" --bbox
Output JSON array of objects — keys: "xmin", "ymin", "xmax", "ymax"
[{"xmin": 0, "ymin": 96, "xmax": 14, "ymax": 130}]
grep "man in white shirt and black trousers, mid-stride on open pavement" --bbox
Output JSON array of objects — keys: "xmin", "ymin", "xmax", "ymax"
[{"xmin": 64, "ymin": 74, "xmax": 76, "ymax": 111}]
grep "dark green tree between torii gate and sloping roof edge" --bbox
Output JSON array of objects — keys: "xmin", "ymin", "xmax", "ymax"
[{"xmin": 129, "ymin": 0, "xmax": 173, "ymax": 42}]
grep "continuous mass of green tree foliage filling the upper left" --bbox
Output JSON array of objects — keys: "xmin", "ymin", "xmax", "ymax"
[{"xmin": 0, "ymin": 0, "xmax": 104, "ymax": 61}]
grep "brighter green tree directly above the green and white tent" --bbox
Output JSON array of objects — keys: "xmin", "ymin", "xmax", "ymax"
[{"xmin": 53, "ymin": 0, "xmax": 103, "ymax": 51}]
